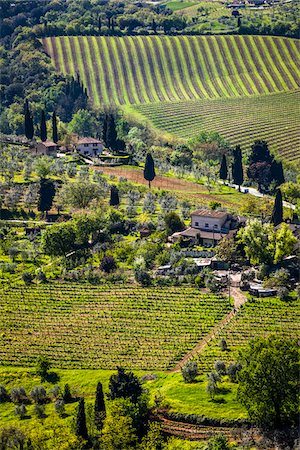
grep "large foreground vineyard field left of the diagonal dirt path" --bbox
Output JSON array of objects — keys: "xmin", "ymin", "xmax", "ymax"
[{"xmin": 0, "ymin": 283, "xmax": 229, "ymax": 369}]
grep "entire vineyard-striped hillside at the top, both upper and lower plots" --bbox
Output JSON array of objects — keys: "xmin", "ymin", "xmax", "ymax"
[{"xmin": 43, "ymin": 36, "xmax": 300, "ymax": 160}]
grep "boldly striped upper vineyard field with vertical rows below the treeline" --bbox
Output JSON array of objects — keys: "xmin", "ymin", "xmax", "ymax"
[{"xmin": 43, "ymin": 36, "xmax": 300, "ymax": 106}]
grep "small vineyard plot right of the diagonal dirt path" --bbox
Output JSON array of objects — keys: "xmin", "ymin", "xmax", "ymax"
[{"xmin": 200, "ymin": 298, "xmax": 300, "ymax": 371}]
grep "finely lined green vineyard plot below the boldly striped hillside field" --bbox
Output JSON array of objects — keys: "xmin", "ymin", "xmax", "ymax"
[{"xmin": 134, "ymin": 90, "xmax": 300, "ymax": 161}]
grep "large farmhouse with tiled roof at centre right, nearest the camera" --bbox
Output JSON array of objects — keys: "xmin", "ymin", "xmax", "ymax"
[{"xmin": 169, "ymin": 209, "xmax": 244, "ymax": 246}]
